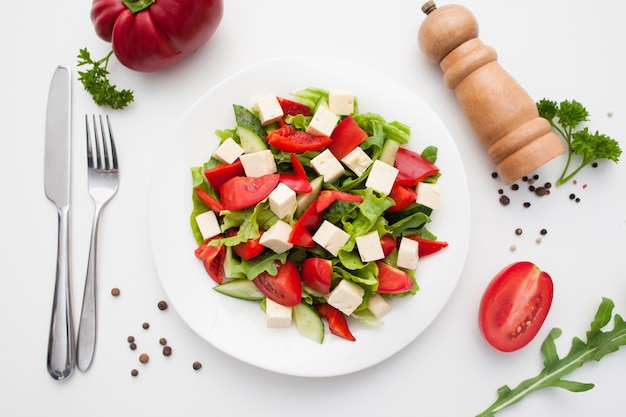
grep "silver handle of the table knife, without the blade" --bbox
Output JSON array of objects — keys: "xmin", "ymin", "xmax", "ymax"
[{"xmin": 47, "ymin": 206, "xmax": 75, "ymax": 380}]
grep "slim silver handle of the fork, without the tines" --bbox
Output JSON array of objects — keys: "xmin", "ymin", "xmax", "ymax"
[{"xmin": 76, "ymin": 207, "xmax": 100, "ymax": 372}]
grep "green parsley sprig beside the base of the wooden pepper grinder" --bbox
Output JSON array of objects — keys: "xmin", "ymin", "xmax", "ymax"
[{"xmin": 537, "ymin": 98, "xmax": 622, "ymax": 185}]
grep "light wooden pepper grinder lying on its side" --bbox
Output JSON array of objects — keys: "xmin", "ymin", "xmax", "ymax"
[{"xmin": 418, "ymin": 1, "xmax": 565, "ymax": 184}]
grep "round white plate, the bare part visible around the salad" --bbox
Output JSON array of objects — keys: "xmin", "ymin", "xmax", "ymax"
[{"xmin": 150, "ymin": 56, "xmax": 470, "ymax": 377}]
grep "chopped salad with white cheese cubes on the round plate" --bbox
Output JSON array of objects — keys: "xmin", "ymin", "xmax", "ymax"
[{"xmin": 190, "ymin": 87, "xmax": 448, "ymax": 343}]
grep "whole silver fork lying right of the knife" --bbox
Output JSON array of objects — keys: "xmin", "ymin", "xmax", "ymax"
[{"xmin": 76, "ymin": 115, "xmax": 119, "ymax": 371}]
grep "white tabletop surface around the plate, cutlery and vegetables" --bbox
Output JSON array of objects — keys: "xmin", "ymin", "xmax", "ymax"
[{"xmin": 0, "ymin": 0, "xmax": 626, "ymax": 417}]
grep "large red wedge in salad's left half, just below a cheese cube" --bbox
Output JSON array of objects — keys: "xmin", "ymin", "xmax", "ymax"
[{"xmin": 220, "ymin": 174, "xmax": 280, "ymax": 210}]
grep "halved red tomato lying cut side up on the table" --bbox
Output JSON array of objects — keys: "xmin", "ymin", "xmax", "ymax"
[{"xmin": 479, "ymin": 261, "xmax": 554, "ymax": 352}]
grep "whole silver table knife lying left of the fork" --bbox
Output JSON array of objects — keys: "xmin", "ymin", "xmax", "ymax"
[{"xmin": 44, "ymin": 66, "xmax": 75, "ymax": 380}]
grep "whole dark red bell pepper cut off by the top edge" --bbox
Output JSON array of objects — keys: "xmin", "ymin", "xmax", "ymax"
[{"xmin": 91, "ymin": 0, "xmax": 224, "ymax": 72}]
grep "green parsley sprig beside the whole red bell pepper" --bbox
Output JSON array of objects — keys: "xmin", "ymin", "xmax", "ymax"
[{"xmin": 78, "ymin": 48, "xmax": 134, "ymax": 109}]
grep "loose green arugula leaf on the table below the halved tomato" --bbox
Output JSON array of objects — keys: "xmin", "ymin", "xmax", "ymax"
[{"xmin": 476, "ymin": 298, "xmax": 626, "ymax": 417}]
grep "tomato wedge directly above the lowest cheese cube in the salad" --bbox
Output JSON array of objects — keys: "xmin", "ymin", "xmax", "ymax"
[{"xmin": 252, "ymin": 259, "xmax": 302, "ymax": 307}]
